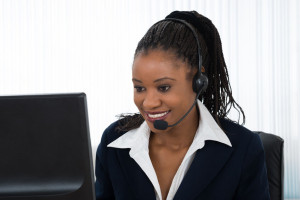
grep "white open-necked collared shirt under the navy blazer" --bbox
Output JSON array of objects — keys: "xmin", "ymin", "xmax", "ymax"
[{"xmin": 107, "ymin": 100, "xmax": 231, "ymax": 200}]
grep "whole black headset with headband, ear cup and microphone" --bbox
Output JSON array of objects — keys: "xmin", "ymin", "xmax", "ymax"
[{"xmin": 153, "ymin": 18, "xmax": 208, "ymax": 130}]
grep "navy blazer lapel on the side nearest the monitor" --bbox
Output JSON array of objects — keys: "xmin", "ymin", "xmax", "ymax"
[{"xmin": 118, "ymin": 149, "xmax": 156, "ymax": 200}]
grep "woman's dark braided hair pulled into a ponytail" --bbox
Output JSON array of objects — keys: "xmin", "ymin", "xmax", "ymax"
[{"xmin": 117, "ymin": 11, "xmax": 245, "ymax": 131}]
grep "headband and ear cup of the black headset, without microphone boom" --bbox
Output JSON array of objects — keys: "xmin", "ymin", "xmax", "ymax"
[{"xmin": 156, "ymin": 18, "xmax": 208, "ymax": 94}]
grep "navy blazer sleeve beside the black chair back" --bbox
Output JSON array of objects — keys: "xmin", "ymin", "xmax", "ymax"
[{"xmin": 235, "ymin": 134, "xmax": 270, "ymax": 200}]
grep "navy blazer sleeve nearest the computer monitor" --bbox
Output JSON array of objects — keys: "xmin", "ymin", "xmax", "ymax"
[{"xmin": 95, "ymin": 129, "xmax": 115, "ymax": 200}]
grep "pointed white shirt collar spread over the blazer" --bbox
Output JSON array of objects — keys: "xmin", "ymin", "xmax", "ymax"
[{"xmin": 107, "ymin": 100, "xmax": 232, "ymax": 152}]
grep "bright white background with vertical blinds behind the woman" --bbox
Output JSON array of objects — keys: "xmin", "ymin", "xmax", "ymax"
[{"xmin": 0, "ymin": 0, "xmax": 300, "ymax": 198}]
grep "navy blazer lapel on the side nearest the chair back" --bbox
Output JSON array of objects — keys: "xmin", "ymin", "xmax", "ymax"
[{"xmin": 174, "ymin": 141, "xmax": 233, "ymax": 200}]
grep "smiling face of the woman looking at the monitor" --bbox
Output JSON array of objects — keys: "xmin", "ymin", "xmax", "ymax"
[{"xmin": 132, "ymin": 50, "xmax": 196, "ymax": 132}]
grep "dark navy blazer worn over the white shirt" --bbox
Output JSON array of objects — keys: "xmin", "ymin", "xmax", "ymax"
[{"xmin": 95, "ymin": 120, "xmax": 270, "ymax": 200}]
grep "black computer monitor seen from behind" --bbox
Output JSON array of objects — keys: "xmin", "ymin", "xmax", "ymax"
[{"xmin": 0, "ymin": 93, "xmax": 95, "ymax": 200}]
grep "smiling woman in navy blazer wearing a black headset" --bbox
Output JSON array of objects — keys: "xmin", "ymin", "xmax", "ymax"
[{"xmin": 95, "ymin": 11, "xmax": 270, "ymax": 200}]
